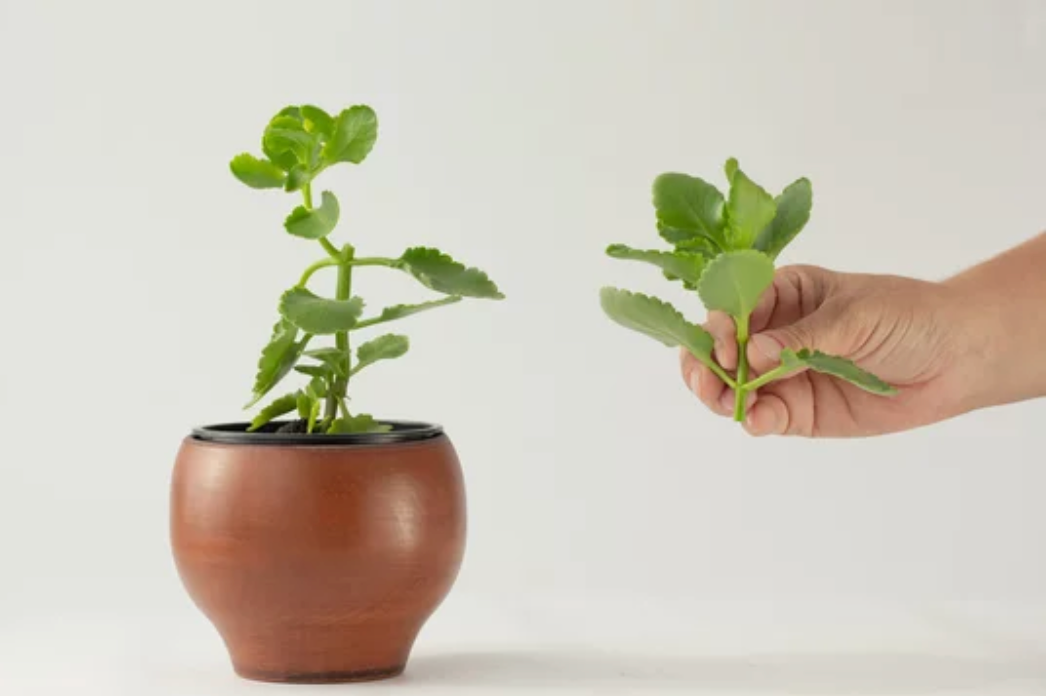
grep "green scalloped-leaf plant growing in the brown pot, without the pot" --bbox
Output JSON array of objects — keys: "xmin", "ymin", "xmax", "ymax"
[{"xmin": 230, "ymin": 106, "xmax": 504, "ymax": 433}]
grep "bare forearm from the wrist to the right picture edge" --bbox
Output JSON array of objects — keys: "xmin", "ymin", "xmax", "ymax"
[{"xmin": 945, "ymin": 233, "xmax": 1046, "ymax": 408}]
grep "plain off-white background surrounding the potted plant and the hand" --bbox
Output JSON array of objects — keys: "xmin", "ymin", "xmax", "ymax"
[{"xmin": 0, "ymin": 0, "xmax": 1046, "ymax": 694}]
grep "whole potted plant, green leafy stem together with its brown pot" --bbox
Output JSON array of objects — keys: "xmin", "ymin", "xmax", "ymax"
[{"xmin": 170, "ymin": 106, "xmax": 503, "ymax": 682}]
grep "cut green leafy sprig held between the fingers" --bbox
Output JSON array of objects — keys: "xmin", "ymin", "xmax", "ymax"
[{"xmin": 600, "ymin": 158, "xmax": 894, "ymax": 422}]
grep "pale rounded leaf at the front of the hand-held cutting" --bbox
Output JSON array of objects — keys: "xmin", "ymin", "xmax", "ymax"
[{"xmin": 698, "ymin": 249, "xmax": 774, "ymax": 321}]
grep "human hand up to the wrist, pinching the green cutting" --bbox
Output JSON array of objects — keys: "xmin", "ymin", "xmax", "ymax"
[{"xmin": 682, "ymin": 266, "xmax": 984, "ymax": 437}]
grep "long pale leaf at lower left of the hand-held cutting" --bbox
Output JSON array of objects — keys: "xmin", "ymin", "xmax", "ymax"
[{"xmin": 599, "ymin": 288, "xmax": 712, "ymax": 362}]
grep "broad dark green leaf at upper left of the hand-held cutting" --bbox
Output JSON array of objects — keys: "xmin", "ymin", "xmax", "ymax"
[{"xmin": 654, "ymin": 172, "xmax": 726, "ymax": 248}]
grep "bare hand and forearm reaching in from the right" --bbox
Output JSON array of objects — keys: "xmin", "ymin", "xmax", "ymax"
[{"xmin": 681, "ymin": 233, "xmax": 1046, "ymax": 437}]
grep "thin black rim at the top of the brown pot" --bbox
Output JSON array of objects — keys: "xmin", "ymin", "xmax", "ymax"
[{"xmin": 190, "ymin": 420, "xmax": 444, "ymax": 447}]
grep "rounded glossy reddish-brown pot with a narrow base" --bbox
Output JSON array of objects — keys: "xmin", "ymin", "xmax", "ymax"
[{"xmin": 170, "ymin": 423, "xmax": 465, "ymax": 682}]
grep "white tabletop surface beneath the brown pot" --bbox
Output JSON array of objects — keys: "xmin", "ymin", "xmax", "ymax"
[{"xmin": 0, "ymin": 598, "xmax": 1046, "ymax": 696}]
